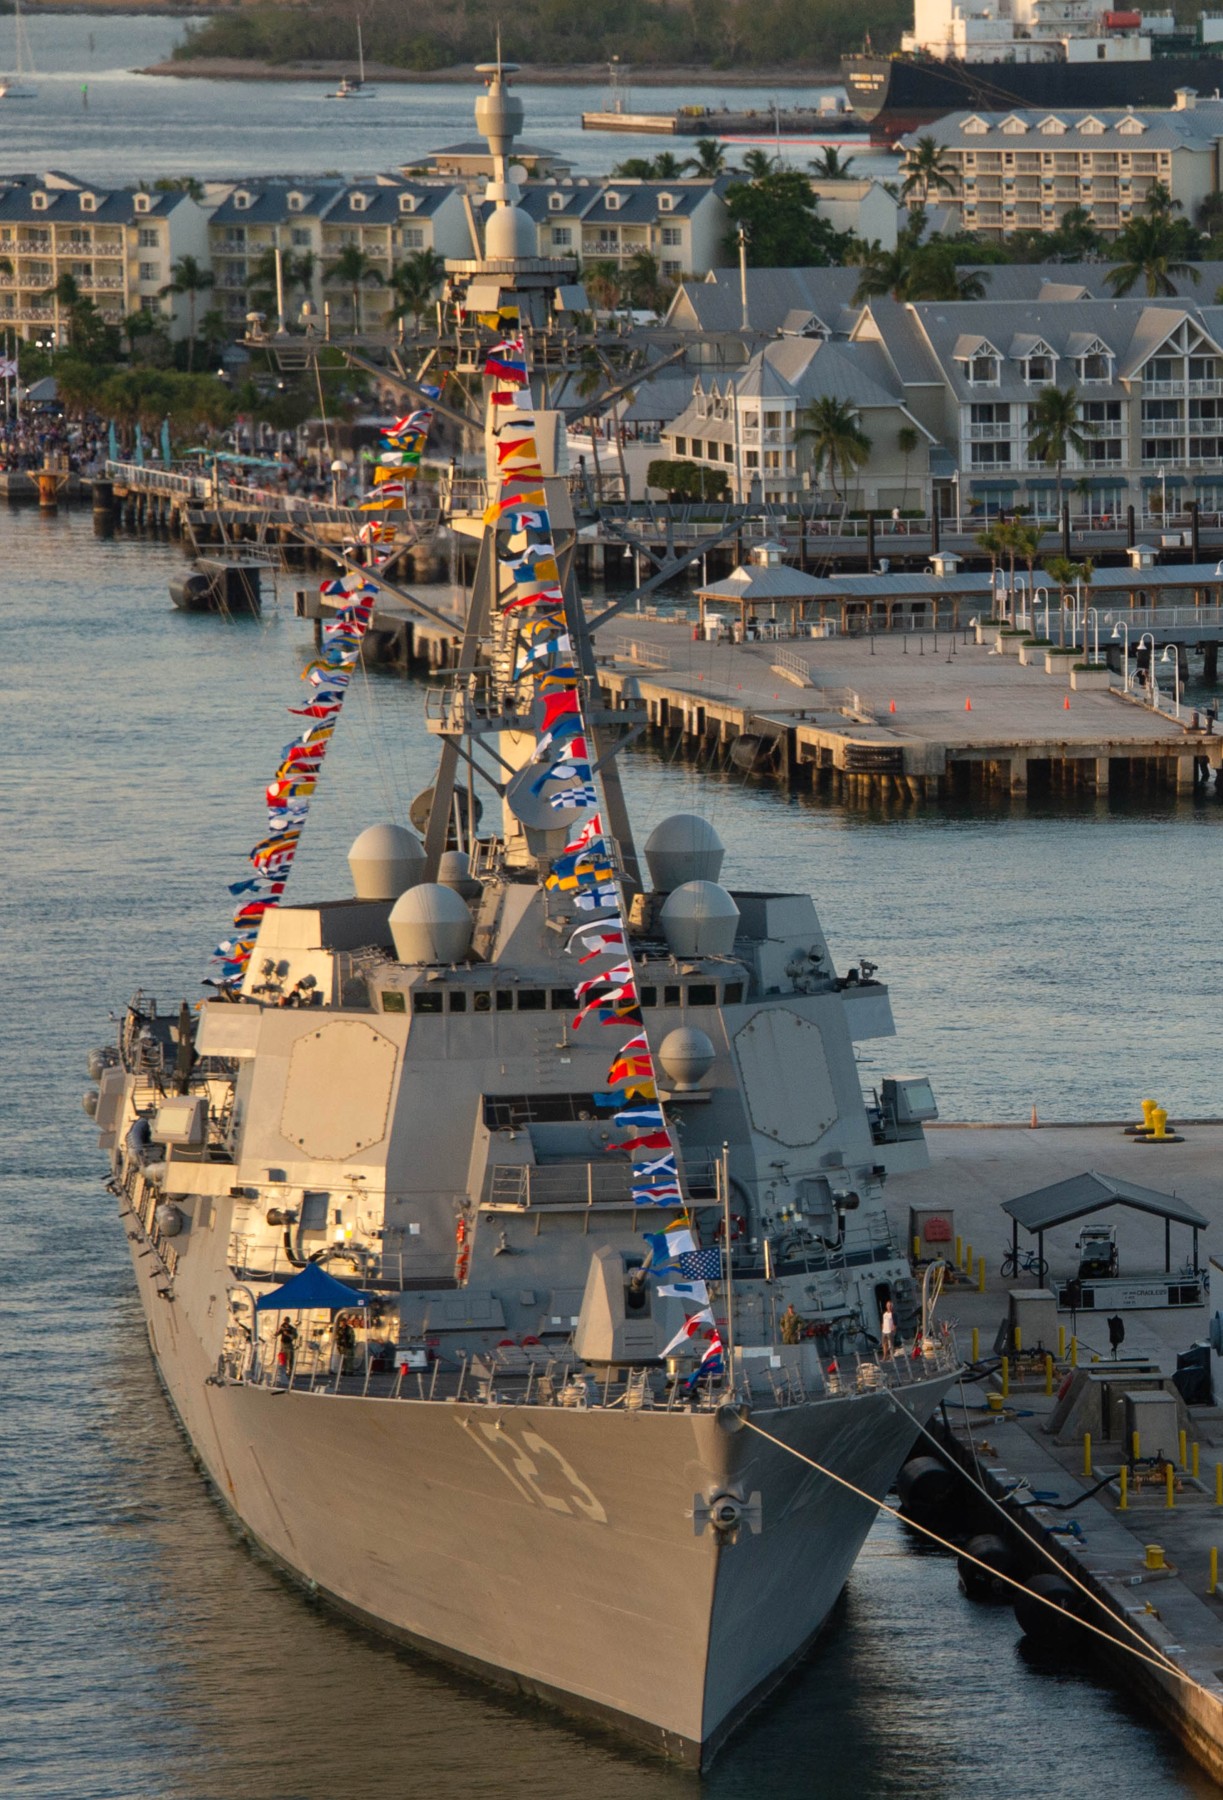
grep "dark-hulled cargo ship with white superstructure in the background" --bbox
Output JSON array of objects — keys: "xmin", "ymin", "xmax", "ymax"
[{"xmin": 841, "ymin": 0, "xmax": 1223, "ymax": 144}]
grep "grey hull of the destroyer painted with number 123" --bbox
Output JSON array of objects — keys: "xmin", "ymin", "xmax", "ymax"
[{"xmin": 131, "ymin": 1233, "xmax": 951, "ymax": 1766}]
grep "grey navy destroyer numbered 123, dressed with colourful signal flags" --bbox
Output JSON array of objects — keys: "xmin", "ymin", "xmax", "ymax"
[{"xmin": 86, "ymin": 65, "xmax": 958, "ymax": 1764}]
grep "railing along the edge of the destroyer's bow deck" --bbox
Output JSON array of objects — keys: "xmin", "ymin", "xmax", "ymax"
[{"xmin": 216, "ymin": 1330, "xmax": 960, "ymax": 1413}]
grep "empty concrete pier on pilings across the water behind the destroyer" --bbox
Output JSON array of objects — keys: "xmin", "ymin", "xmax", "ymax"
[{"xmin": 598, "ymin": 619, "xmax": 1223, "ymax": 801}]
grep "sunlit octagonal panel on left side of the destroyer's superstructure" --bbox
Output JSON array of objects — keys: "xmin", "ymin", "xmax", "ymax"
[{"xmin": 281, "ymin": 1019, "xmax": 398, "ymax": 1163}]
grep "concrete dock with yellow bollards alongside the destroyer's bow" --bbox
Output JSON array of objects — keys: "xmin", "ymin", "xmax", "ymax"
[{"xmin": 888, "ymin": 1121, "xmax": 1223, "ymax": 1782}]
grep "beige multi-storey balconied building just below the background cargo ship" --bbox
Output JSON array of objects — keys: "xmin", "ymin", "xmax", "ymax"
[{"xmin": 901, "ymin": 91, "xmax": 1223, "ymax": 238}]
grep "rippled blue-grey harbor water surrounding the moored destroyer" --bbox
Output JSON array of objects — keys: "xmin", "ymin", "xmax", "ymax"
[{"xmin": 0, "ymin": 509, "xmax": 1223, "ymax": 1800}]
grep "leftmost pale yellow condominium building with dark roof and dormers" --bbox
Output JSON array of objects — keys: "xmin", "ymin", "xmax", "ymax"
[{"xmin": 0, "ymin": 175, "xmax": 209, "ymax": 346}]
